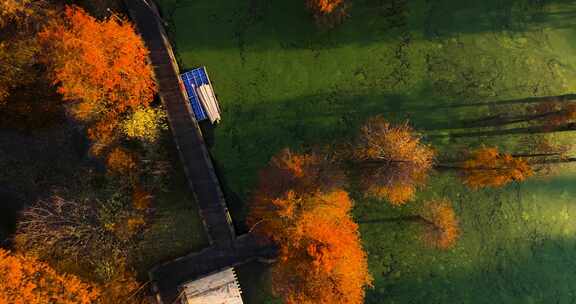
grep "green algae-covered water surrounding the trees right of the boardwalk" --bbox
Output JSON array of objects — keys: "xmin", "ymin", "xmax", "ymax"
[{"xmin": 159, "ymin": 0, "xmax": 576, "ymax": 303}]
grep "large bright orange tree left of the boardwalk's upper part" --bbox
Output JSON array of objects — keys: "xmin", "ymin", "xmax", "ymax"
[{"xmin": 39, "ymin": 6, "xmax": 156, "ymax": 154}]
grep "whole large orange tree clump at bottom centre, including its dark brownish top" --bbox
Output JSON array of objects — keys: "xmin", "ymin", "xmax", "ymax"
[{"xmin": 248, "ymin": 150, "xmax": 371, "ymax": 304}]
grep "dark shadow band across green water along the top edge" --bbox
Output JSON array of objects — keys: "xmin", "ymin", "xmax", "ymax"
[{"xmin": 161, "ymin": 0, "xmax": 576, "ymax": 53}]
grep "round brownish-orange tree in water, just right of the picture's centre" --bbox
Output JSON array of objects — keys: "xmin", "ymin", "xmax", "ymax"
[{"xmin": 353, "ymin": 116, "xmax": 435, "ymax": 205}]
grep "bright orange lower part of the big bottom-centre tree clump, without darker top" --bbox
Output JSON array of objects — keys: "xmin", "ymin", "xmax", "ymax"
[{"xmin": 256, "ymin": 190, "xmax": 371, "ymax": 304}]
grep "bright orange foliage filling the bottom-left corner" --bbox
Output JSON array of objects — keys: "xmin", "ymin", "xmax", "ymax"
[{"xmin": 0, "ymin": 248, "xmax": 100, "ymax": 304}]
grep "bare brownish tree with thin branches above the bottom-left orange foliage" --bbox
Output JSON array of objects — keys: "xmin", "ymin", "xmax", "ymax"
[{"xmin": 15, "ymin": 196, "xmax": 138, "ymax": 276}]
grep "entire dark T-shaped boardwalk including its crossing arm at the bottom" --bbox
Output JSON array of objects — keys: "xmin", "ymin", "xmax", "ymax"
[{"xmin": 124, "ymin": 0, "xmax": 276, "ymax": 304}]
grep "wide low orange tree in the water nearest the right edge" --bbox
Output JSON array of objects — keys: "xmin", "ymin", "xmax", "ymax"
[{"xmin": 463, "ymin": 147, "xmax": 533, "ymax": 189}]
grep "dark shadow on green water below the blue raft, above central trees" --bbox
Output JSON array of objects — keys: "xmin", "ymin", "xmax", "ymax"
[{"xmin": 211, "ymin": 92, "xmax": 472, "ymax": 204}]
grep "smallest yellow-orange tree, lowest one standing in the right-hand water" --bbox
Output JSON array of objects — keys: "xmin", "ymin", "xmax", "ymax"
[{"xmin": 420, "ymin": 199, "xmax": 460, "ymax": 249}]
